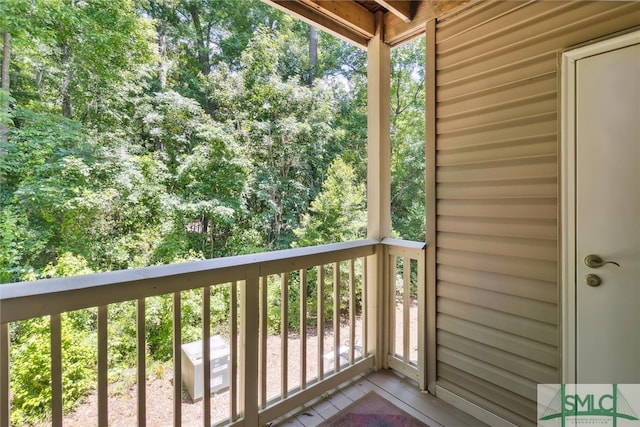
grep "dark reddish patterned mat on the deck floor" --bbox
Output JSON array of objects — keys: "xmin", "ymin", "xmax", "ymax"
[{"xmin": 320, "ymin": 391, "xmax": 428, "ymax": 427}]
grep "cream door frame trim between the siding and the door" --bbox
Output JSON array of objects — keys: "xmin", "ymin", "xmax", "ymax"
[{"xmin": 559, "ymin": 30, "xmax": 640, "ymax": 383}]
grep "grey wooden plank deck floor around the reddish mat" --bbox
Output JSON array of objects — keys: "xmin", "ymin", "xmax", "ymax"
[{"xmin": 270, "ymin": 370, "xmax": 487, "ymax": 427}]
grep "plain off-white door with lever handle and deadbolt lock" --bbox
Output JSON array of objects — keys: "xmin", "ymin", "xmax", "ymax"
[{"xmin": 574, "ymin": 33, "xmax": 640, "ymax": 384}]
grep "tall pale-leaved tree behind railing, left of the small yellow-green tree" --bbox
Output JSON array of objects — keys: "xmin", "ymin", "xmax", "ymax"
[{"xmin": 239, "ymin": 25, "xmax": 340, "ymax": 248}]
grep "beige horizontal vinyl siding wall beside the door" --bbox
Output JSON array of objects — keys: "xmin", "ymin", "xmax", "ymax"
[{"xmin": 435, "ymin": 1, "xmax": 640, "ymax": 426}]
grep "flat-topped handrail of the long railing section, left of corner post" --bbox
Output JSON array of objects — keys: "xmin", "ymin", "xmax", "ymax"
[{"xmin": 0, "ymin": 239, "xmax": 378, "ymax": 323}]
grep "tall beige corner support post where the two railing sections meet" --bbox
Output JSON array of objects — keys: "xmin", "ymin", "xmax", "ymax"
[{"xmin": 367, "ymin": 12, "xmax": 391, "ymax": 369}]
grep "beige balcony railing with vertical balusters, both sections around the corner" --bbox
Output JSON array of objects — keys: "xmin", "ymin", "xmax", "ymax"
[{"xmin": 0, "ymin": 239, "xmax": 426, "ymax": 427}]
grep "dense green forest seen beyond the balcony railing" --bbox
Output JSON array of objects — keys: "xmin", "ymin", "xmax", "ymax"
[{"xmin": 0, "ymin": 0, "xmax": 424, "ymax": 422}]
